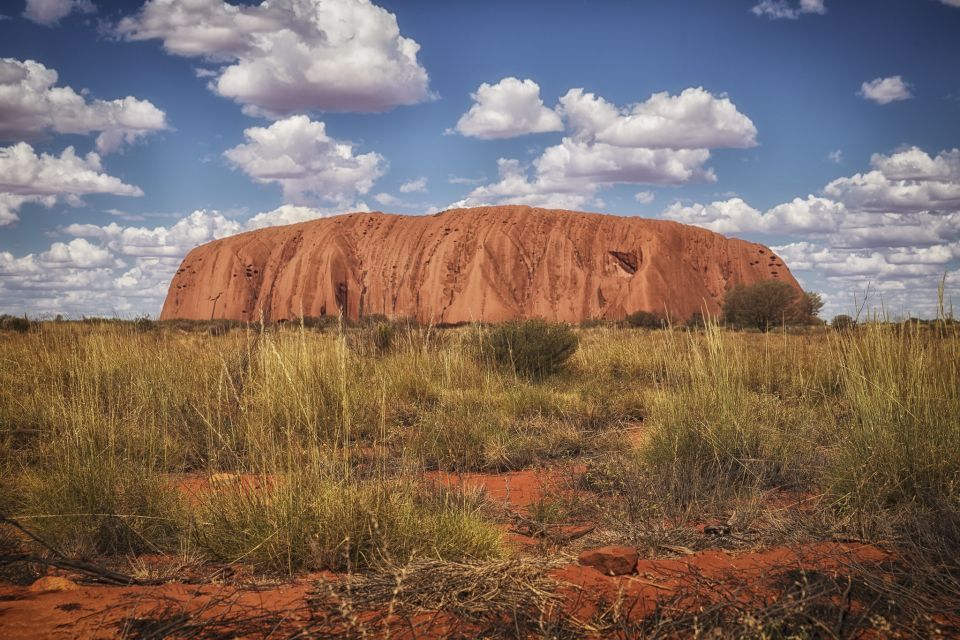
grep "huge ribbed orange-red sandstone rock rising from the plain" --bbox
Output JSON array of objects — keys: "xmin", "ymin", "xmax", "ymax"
[{"xmin": 160, "ymin": 206, "xmax": 799, "ymax": 324}]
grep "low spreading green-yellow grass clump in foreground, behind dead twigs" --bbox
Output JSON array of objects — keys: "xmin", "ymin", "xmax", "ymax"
[{"xmin": 195, "ymin": 473, "xmax": 502, "ymax": 573}]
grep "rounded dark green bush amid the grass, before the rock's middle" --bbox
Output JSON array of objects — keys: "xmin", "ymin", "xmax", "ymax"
[{"xmin": 487, "ymin": 320, "xmax": 579, "ymax": 379}]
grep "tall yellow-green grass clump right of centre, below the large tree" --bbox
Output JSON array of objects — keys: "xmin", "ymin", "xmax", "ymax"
[{"xmin": 642, "ymin": 324, "xmax": 819, "ymax": 502}]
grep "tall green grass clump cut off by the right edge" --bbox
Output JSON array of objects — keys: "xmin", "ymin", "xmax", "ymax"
[{"xmin": 827, "ymin": 323, "xmax": 960, "ymax": 552}]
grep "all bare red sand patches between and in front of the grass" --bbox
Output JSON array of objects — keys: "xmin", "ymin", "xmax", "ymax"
[{"xmin": 0, "ymin": 470, "xmax": 908, "ymax": 640}]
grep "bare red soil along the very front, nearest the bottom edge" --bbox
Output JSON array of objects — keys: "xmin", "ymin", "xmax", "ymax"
[{"xmin": 0, "ymin": 543, "xmax": 888, "ymax": 640}]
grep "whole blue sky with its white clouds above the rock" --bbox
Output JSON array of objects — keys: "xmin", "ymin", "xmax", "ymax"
[{"xmin": 0, "ymin": 0, "xmax": 960, "ymax": 317}]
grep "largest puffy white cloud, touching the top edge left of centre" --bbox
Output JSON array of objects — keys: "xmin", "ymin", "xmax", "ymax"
[{"xmin": 117, "ymin": 0, "xmax": 430, "ymax": 117}]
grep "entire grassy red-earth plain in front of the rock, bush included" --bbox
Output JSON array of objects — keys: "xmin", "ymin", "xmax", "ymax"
[{"xmin": 0, "ymin": 298, "xmax": 960, "ymax": 638}]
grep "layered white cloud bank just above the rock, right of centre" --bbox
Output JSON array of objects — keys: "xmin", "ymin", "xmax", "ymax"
[{"xmin": 456, "ymin": 87, "xmax": 757, "ymax": 208}]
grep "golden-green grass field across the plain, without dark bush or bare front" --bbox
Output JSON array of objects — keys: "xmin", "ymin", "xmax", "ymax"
[{"xmin": 0, "ymin": 322, "xmax": 960, "ymax": 572}]
